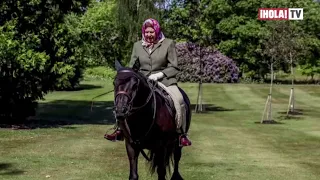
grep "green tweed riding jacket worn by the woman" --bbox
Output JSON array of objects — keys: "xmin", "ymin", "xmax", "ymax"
[{"xmin": 129, "ymin": 38, "xmax": 180, "ymax": 86}]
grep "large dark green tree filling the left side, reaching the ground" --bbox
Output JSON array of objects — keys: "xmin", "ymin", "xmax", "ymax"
[{"xmin": 0, "ymin": 0, "xmax": 89, "ymax": 122}]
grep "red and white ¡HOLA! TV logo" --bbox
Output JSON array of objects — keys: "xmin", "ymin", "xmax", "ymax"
[{"xmin": 258, "ymin": 8, "xmax": 303, "ymax": 21}]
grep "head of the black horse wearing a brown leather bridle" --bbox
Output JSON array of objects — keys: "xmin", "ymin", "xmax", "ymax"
[{"xmin": 113, "ymin": 62, "xmax": 146, "ymax": 119}]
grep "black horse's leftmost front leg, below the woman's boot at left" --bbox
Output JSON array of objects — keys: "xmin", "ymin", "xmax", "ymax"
[{"xmin": 126, "ymin": 140, "xmax": 140, "ymax": 180}]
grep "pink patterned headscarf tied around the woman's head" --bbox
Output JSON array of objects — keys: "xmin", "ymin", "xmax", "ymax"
[{"xmin": 142, "ymin": 18, "xmax": 165, "ymax": 47}]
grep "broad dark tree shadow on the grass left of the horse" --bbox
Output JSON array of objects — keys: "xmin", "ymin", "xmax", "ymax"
[{"xmin": 1, "ymin": 100, "xmax": 115, "ymax": 129}]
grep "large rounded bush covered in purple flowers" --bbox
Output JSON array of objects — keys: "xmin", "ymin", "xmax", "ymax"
[{"xmin": 176, "ymin": 43, "xmax": 239, "ymax": 83}]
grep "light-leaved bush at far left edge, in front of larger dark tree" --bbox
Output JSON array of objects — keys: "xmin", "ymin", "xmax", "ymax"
[{"xmin": 0, "ymin": 22, "xmax": 49, "ymax": 123}]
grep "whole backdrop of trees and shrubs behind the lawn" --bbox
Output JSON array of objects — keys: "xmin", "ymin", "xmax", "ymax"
[{"xmin": 0, "ymin": 0, "xmax": 320, "ymax": 122}]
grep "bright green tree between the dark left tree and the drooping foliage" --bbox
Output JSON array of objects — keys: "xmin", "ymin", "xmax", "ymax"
[{"xmin": 65, "ymin": 0, "xmax": 120, "ymax": 67}]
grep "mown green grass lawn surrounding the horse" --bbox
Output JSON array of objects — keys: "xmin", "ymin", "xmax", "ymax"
[{"xmin": 0, "ymin": 81, "xmax": 320, "ymax": 180}]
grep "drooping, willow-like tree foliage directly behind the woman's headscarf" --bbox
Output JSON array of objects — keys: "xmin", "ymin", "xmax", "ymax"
[{"xmin": 114, "ymin": 0, "xmax": 168, "ymax": 64}]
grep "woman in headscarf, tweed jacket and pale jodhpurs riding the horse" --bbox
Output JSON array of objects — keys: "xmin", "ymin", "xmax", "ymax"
[{"xmin": 105, "ymin": 18, "xmax": 191, "ymax": 146}]
